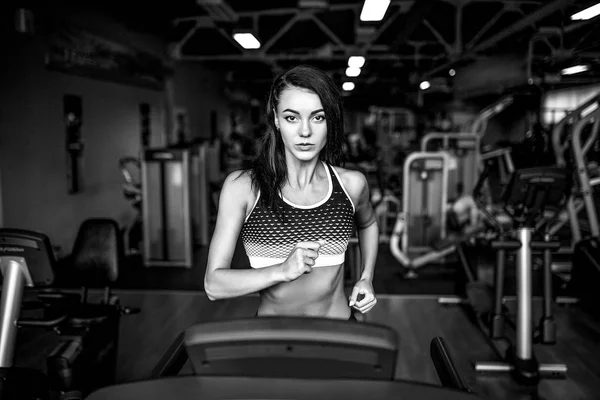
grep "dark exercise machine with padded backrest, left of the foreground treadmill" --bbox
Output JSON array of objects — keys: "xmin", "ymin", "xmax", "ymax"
[{"xmin": 43, "ymin": 218, "xmax": 140, "ymax": 395}]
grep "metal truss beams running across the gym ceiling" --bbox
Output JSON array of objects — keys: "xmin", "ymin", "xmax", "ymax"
[{"xmin": 165, "ymin": 0, "xmax": 598, "ymax": 90}]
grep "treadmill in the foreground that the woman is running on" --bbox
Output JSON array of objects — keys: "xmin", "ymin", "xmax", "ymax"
[{"xmin": 83, "ymin": 317, "xmax": 477, "ymax": 400}]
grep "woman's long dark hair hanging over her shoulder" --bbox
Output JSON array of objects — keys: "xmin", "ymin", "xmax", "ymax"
[{"xmin": 250, "ymin": 65, "xmax": 345, "ymax": 216}]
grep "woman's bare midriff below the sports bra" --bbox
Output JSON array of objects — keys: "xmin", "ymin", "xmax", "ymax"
[{"xmin": 258, "ymin": 265, "xmax": 351, "ymax": 319}]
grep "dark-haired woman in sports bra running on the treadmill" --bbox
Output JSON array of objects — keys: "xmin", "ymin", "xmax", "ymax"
[{"xmin": 204, "ymin": 66, "xmax": 379, "ymax": 319}]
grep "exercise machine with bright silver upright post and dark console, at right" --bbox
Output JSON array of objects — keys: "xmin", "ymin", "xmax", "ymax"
[{"xmin": 440, "ymin": 167, "xmax": 571, "ymax": 385}]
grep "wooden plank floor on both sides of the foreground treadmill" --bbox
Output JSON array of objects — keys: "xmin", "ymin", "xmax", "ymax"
[{"xmin": 16, "ymin": 291, "xmax": 600, "ymax": 400}]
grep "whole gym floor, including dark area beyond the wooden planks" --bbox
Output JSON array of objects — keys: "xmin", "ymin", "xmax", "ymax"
[{"xmin": 15, "ymin": 239, "xmax": 600, "ymax": 400}]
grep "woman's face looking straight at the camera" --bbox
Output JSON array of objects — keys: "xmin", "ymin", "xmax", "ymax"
[{"xmin": 275, "ymin": 87, "xmax": 327, "ymax": 161}]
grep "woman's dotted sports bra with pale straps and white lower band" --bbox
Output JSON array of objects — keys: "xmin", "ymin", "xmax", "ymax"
[{"xmin": 241, "ymin": 163, "xmax": 355, "ymax": 268}]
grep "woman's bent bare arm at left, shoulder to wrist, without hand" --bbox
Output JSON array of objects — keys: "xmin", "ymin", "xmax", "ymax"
[{"xmin": 204, "ymin": 172, "xmax": 286, "ymax": 300}]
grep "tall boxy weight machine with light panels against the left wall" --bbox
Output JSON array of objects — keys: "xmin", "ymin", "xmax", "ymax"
[{"xmin": 142, "ymin": 143, "xmax": 211, "ymax": 268}]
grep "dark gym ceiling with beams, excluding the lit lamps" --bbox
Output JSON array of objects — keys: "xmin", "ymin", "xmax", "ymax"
[{"xmin": 51, "ymin": 0, "xmax": 600, "ymax": 104}]
